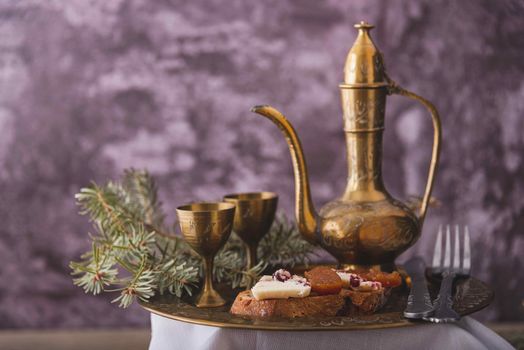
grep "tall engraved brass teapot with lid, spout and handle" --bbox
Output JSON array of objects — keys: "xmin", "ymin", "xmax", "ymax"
[{"xmin": 252, "ymin": 22, "xmax": 441, "ymax": 270}]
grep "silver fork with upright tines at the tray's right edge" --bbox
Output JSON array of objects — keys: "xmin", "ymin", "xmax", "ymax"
[{"xmin": 424, "ymin": 225, "xmax": 471, "ymax": 323}]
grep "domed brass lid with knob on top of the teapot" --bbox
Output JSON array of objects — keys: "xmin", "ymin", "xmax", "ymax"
[{"xmin": 342, "ymin": 21, "xmax": 388, "ymax": 88}]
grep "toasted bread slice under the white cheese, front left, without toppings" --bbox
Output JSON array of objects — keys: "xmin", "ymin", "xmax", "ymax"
[{"xmin": 231, "ymin": 290, "xmax": 345, "ymax": 318}]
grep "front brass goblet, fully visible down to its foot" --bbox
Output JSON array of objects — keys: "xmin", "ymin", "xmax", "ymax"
[{"xmin": 176, "ymin": 202, "xmax": 235, "ymax": 307}]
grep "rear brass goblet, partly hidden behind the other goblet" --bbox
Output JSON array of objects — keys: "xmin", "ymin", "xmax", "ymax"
[{"xmin": 224, "ymin": 192, "xmax": 278, "ymax": 269}]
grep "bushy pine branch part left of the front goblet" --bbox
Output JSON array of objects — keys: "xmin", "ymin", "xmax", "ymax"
[{"xmin": 70, "ymin": 169, "xmax": 200, "ymax": 307}]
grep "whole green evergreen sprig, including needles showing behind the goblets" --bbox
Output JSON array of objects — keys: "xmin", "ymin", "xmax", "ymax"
[{"xmin": 70, "ymin": 169, "xmax": 313, "ymax": 308}]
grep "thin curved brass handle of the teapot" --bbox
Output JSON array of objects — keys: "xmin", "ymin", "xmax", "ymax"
[{"xmin": 386, "ymin": 76, "xmax": 442, "ymax": 228}]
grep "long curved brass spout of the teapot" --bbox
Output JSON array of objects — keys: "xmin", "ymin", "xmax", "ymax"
[{"xmin": 251, "ymin": 105, "xmax": 319, "ymax": 244}]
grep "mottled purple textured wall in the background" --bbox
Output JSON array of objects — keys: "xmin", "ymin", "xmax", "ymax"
[{"xmin": 0, "ymin": 0, "xmax": 524, "ymax": 327}]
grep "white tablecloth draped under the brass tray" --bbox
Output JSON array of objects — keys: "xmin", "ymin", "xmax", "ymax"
[{"xmin": 149, "ymin": 314, "xmax": 513, "ymax": 350}]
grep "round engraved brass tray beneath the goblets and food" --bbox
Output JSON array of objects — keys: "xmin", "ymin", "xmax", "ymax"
[{"xmin": 140, "ymin": 268, "xmax": 493, "ymax": 331}]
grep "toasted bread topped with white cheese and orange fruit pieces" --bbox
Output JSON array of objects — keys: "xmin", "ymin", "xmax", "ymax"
[{"xmin": 231, "ymin": 266, "xmax": 402, "ymax": 318}]
